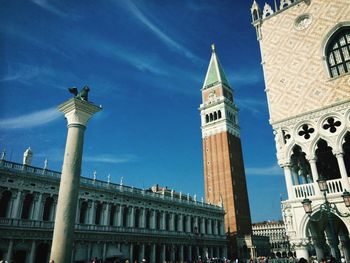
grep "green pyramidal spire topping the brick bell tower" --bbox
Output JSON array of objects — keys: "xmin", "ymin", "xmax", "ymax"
[{"xmin": 203, "ymin": 44, "xmax": 231, "ymax": 89}]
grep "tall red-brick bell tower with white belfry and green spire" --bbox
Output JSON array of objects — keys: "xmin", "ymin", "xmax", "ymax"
[{"xmin": 199, "ymin": 44, "xmax": 251, "ymax": 239}]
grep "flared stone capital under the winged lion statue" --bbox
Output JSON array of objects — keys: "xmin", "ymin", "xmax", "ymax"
[{"xmin": 57, "ymin": 98, "xmax": 101, "ymax": 127}]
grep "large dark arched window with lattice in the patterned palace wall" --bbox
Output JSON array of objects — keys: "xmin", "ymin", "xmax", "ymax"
[{"xmin": 326, "ymin": 27, "xmax": 350, "ymax": 78}]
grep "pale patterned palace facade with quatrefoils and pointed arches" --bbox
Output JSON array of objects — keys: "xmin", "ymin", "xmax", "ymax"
[{"xmin": 251, "ymin": 0, "xmax": 350, "ymax": 261}]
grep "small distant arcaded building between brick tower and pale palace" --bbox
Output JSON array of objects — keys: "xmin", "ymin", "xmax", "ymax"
[{"xmin": 252, "ymin": 220, "xmax": 294, "ymax": 258}]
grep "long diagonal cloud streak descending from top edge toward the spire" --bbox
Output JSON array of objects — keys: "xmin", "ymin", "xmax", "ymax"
[{"xmin": 126, "ymin": 1, "xmax": 204, "ymax": 63}]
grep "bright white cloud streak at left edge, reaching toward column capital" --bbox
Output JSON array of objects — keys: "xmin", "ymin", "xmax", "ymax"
[{"xmin": 0, "ymin": 108, "xmax": 62, "ymax": 130}]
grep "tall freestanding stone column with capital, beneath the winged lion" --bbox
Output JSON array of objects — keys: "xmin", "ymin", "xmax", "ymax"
[{"xmin": 51, "ymin": 98, "xmax": 101, "ymax": 262}]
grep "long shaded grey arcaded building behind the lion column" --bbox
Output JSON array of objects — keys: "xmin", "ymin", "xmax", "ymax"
[{"xmin": 0, "ymin": 156, "xmax": 227, "ymax": 263}]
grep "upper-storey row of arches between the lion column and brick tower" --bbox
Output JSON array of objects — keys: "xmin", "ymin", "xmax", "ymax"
[{"xmin": 78, "ymin": 201, "xmax": 223, "ymax": 235}]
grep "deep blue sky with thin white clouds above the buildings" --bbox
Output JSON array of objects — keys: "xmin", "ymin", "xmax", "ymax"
[{"xmin": 0, "ymin": 0, "xmax": 286, "ymax": 222}]
